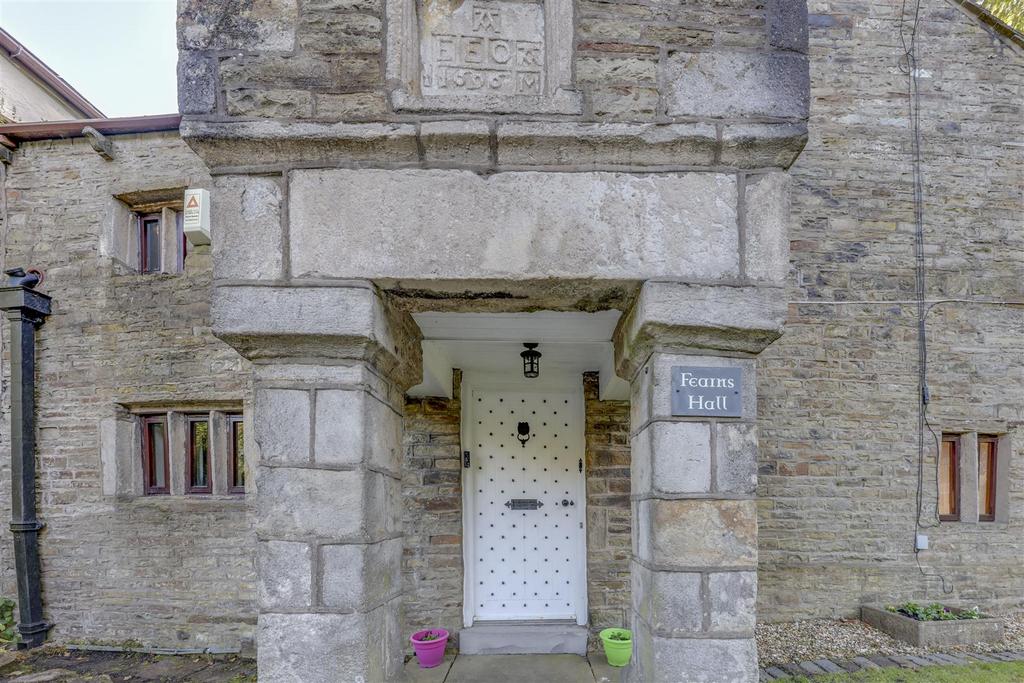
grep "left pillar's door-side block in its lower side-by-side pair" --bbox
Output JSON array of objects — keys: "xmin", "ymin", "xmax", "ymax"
[{"xmin": 319, "ymin": 539, "xmax": 401, "ymax": 611}]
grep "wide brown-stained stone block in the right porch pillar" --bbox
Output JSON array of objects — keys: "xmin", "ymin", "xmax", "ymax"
[{"xmin": 636, "ymin": 499, "xmax": 758, "ymax": 568}]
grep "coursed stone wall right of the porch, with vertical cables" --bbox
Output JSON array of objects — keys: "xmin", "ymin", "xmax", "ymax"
[{"xmin": 759, "ymin": 0, "xmax": 1024, "ymax": 621}]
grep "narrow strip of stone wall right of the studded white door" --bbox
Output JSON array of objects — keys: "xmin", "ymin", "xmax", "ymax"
[{"xmin": 584, "ymin": 373, "xmax": 632, "ymax": 649}]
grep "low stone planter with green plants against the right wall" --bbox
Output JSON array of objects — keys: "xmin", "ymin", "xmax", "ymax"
[{"xmin": 860, "ymin": 605, "xmax": 1004, "ymax": 648}]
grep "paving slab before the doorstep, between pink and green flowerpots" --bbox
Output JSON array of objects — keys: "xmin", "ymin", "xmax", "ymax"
[{"xmin": 444, "ymin": 654, "xmax": 594, "ymax": 683}]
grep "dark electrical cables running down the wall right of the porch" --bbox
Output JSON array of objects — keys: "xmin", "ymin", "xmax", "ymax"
[{"xmin": 899, "ymin": 0, "xmax": 953, "ymax": 595}]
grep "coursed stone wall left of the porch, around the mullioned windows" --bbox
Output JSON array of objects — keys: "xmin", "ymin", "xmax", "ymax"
[{"xmin": 0, "ymin": 132, "xmax": 255, "ymax": 648}]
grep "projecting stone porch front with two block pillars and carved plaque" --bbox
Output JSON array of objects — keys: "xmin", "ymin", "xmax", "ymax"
[{"xmin": 179, "ymin": 0, "xmax": 808, "ymax": 680}]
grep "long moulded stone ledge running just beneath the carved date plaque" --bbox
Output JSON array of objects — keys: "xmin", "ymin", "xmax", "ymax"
[{"xmin": 181, "ymin": 117, "xmax": 807, "ymax": 174}]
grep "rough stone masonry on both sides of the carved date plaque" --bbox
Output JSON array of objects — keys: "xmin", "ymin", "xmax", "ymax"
[{"xmin": 178, "ymin": 0, "xmax": 806, "ymax": 122}]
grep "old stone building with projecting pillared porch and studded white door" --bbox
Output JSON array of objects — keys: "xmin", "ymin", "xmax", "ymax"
[{"xmin": 0, "ymin": 0, "xmax": 1024, "ymax": 681}]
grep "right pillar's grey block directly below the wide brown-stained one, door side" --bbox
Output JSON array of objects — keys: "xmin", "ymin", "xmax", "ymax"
[{"xmin": 630, "ymin": 560, "xmax": 703, "ymax": 636}]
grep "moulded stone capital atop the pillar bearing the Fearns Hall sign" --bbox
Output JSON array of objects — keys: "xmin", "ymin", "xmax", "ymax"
[{"xmin": 612, "ymin": 281, "xmax": 786, "ymax": 382}]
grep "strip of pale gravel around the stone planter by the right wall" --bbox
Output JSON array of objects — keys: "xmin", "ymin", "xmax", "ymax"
[{"xmin": 756, "ymin": 612, "xmax": 1024, "ymax": 667}]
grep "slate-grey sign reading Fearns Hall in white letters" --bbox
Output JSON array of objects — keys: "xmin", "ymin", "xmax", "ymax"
[{"xmin": 672, "ymin": 366, "xmax": 743, "ymax": 418}]
